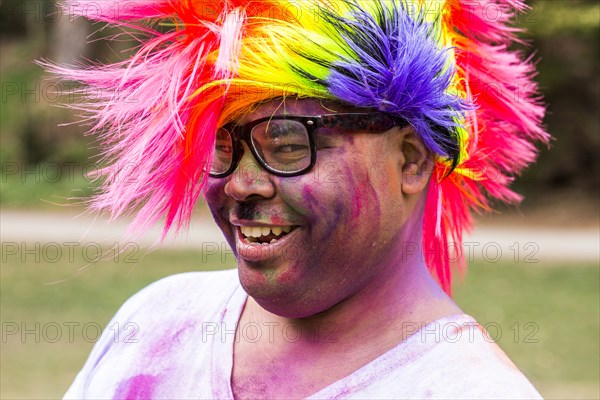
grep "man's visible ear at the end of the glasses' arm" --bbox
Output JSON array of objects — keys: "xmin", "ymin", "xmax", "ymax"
[{"xmin": 401, "ymin": 127, "xmax": 433, "ymax": 195}]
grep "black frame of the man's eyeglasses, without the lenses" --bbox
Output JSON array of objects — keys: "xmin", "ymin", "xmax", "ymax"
[{"xmin": 209, "ymin": 112, "xmax": 409, "ymax": 178}]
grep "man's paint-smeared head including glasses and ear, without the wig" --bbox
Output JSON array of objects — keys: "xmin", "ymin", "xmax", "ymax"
[{"xmin": 206, "ymin": 99, "xmax": 448, "ymax": 318}]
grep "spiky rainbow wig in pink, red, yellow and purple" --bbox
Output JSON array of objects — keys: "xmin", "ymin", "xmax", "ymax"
[{"xmin": 45, "ymin": 0, "xmax": 549, "ymax": 293}]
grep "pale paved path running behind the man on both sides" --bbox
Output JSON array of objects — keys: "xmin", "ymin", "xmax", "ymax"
[{"xmin": 0, "ymin": 210, "xmax": 600, "ymax": 265}]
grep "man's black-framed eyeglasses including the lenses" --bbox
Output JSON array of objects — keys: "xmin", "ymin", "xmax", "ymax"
[{"xmin": 210, "ymin": 113, "xmax": 408, "ymax": 178}]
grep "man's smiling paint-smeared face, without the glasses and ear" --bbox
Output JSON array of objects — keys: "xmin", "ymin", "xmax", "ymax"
[{"xmin": 205, "ymin": 99, "xmax": 414, "ymax": 318}]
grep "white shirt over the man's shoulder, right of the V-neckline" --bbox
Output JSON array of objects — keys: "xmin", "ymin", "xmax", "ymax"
[{"xmin": 311, "ymin": 314, "xmax": 541, "ymax": 399}]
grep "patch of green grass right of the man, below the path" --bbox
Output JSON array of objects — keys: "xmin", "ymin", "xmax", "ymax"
[{"xmin": 455, "ymin": 264, "xmax": 600, "ymax": 398}]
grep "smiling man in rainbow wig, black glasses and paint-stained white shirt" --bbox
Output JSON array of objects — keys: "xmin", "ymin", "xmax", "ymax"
[{"xmin": 52, "ymin": 0, "xmax": 547, "ymax": 399}]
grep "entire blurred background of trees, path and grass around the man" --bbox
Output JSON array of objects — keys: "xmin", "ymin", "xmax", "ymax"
[{"xmin": 0, "ymin": 0, "xmax": 600, "ymax": 399}]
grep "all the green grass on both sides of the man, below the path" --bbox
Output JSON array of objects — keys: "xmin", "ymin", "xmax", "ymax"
[{"xmin": 0, "ymin": 247, "xmax": 599, "ymax": 399}]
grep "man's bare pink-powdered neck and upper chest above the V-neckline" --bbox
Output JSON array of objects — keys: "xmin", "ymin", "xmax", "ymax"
[{"xmin": 232, "ymin": 247, "xmax": 462, "ymax": 398}]
